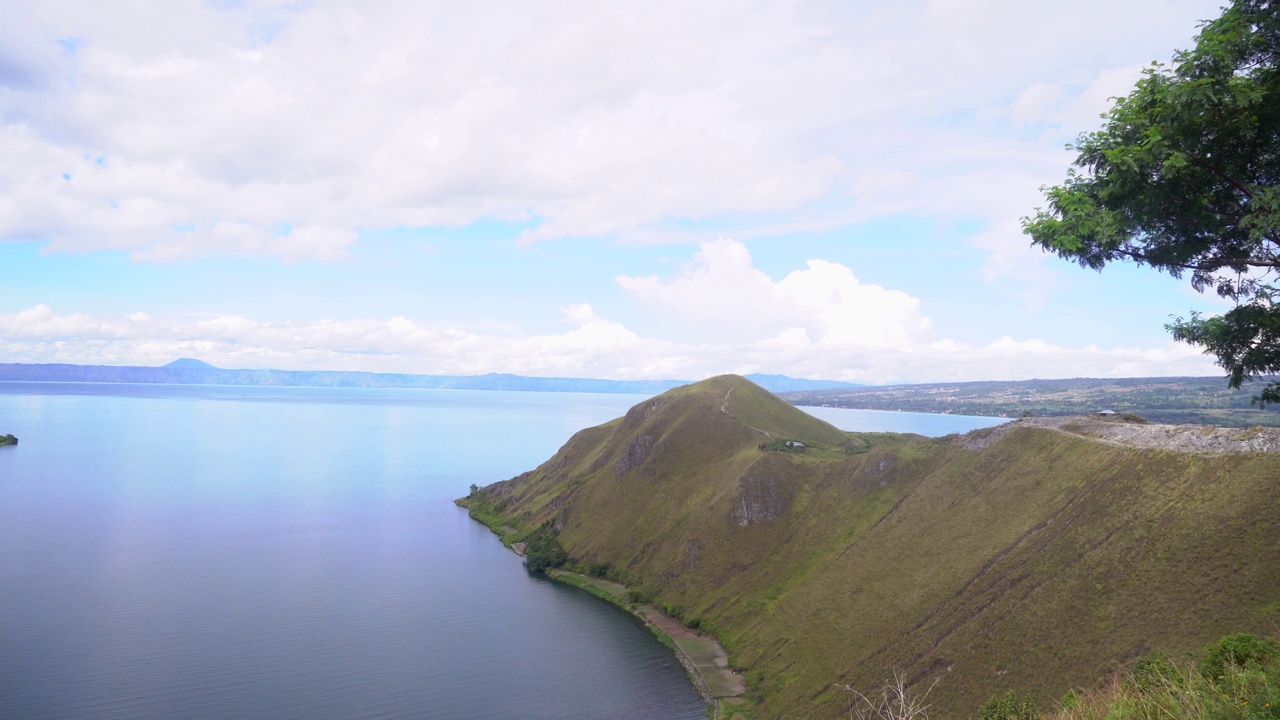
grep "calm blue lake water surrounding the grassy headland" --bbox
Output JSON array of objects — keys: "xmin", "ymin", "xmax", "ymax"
[{"xmin": 0, "ymin": 383, "xmax": 995, "ymax": 720}]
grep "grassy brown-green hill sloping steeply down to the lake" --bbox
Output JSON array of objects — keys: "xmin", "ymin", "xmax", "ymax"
[{"xmin": 471, "ymin": 375, "xmax": 1280, "ymax": 717}]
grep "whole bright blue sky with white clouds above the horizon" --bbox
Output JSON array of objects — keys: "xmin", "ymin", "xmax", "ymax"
[{"xmin": 0, "ymin": 0, "xmax": 1225, "ymax": 383}]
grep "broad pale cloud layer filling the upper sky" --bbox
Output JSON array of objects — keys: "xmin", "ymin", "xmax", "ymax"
[{"xmin": 0, "ymin": 0, "xmax": 1217, "ymax": 260}]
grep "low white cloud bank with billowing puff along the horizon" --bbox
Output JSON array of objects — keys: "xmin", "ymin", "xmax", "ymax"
[{"xmin": 0, "ymin": 240, "xmax": 1215, "ymax": 383}]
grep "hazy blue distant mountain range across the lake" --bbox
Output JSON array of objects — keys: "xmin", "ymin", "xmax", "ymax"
[{"xmin": 0, "ymin": 357, "xmax": 854, "ymax": 395}]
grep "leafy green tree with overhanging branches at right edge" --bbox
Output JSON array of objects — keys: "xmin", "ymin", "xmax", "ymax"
[{"xmin": 1023, "ymin": 0, "xmax": 1280, "ymax": 406}]
